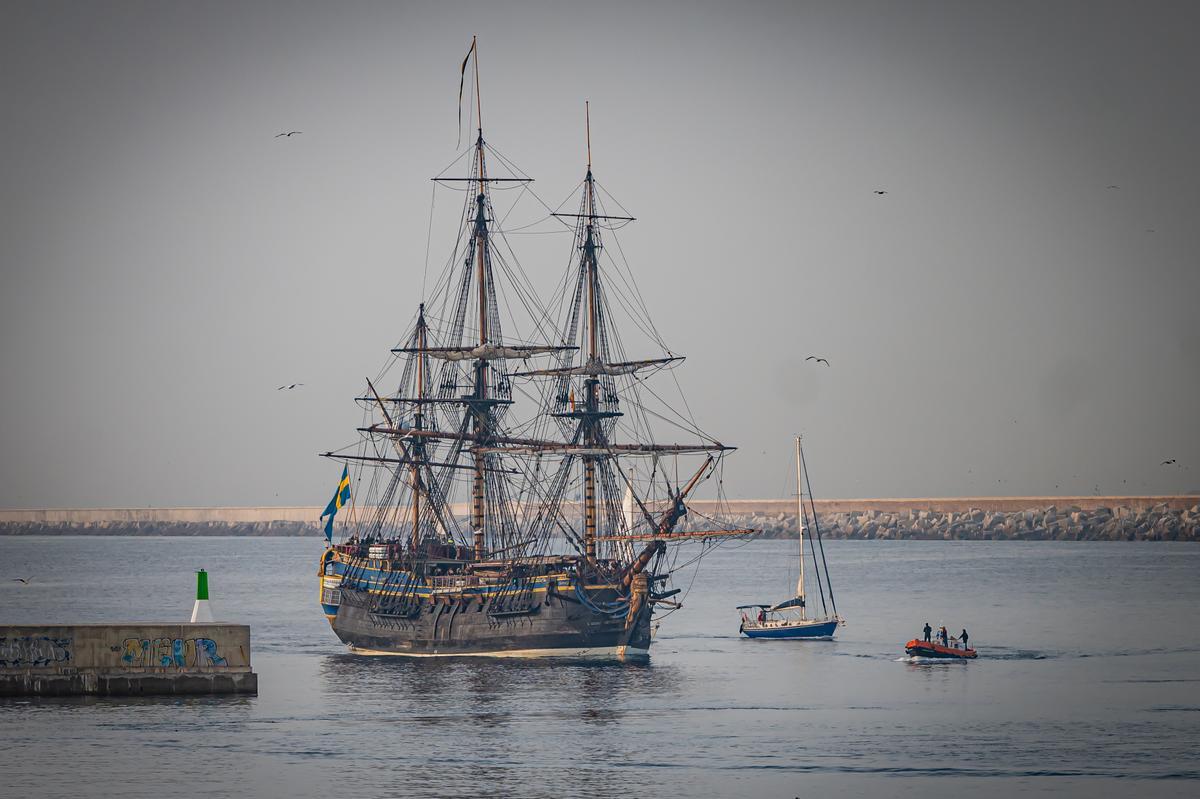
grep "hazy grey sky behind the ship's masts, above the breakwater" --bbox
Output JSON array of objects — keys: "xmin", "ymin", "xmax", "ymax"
[{"xmin": 0, "ymin": 0, "xmax": 1200, "ymax": 506}]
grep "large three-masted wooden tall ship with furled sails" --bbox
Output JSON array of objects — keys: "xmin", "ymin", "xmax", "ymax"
[{"xmin": 318, "ymin": 43, "xmax": 752, "ymax": 657}]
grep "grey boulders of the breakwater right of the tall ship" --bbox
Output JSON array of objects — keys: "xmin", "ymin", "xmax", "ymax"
[{"xmin": 731, "ymin": 499, "xmax": 1200, "ymax": 541}]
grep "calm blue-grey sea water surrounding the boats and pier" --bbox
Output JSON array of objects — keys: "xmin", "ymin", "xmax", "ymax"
[{"xmin": 0, "ymin": 537, "xmax": 1200, "ymax": 799}]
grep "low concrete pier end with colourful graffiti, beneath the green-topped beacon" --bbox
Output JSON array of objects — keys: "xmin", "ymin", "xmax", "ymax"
[{"xmin": 0, "ymin": 623, "xmax": 258, "ymax": 696}]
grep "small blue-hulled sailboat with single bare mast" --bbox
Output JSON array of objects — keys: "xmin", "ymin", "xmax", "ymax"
[{"xmin": 737, "ymin": 435, "xmax": 846, "ymax": 641}]
